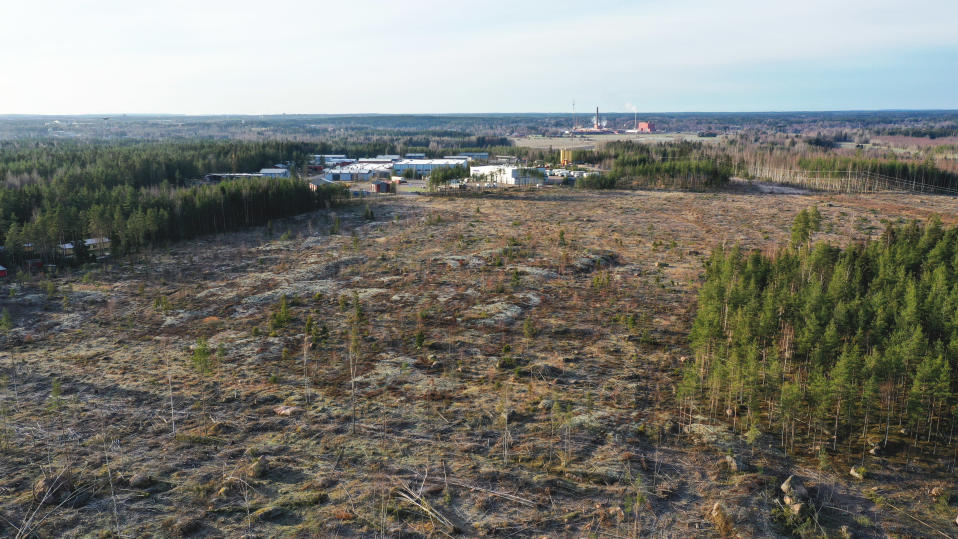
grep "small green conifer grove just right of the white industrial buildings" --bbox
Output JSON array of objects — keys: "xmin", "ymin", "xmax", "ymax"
[{"xmin": 573, "ymin": 142, "xmax": 732, "ymax": 189}]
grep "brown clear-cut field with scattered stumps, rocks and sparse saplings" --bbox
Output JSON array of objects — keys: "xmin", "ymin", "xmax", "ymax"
[{"xmin": 0, "ymin": 188, "xmax": 958, "ymax": 537}]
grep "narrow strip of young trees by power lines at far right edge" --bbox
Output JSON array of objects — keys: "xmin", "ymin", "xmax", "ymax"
[{"xmin": 798, "ymin": 155, "xmax": 958, "ymax": 189}]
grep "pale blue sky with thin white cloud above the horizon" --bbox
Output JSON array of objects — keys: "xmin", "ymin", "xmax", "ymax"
[{"xmin": 0, "ymin": 0, "xmax": 958, "ymax": 115}]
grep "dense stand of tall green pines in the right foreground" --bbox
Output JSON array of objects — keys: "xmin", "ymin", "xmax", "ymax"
[{"xmin": 678, "ymin": 215, "xmax": 958, "ymax": 460}]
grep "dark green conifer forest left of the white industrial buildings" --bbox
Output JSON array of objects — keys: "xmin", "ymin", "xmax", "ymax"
[{"xmin": 0, "ymin": 141, "xmax": 354, "ymax": 266}]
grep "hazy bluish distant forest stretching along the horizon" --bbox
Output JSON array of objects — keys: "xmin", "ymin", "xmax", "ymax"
[{"xmin": 0, "ymin": 110, "xmax": 958, "ymax": 140}]
